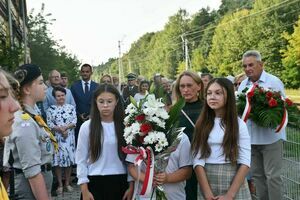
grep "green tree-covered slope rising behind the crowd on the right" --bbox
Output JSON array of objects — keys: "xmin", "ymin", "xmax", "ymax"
[{"xmin": 101, "ymin": 0, "xmax": 300, "ymax": 88}]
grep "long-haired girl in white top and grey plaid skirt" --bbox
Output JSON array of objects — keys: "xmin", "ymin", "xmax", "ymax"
[{"xmin": 192, "ymin": 78, "xmax": 251, "ymax": 200}]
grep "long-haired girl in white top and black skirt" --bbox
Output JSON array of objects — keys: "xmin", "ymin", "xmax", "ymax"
[{"xmin": 76, "ymin": 84, "xmax": 133, "ymax": 200}]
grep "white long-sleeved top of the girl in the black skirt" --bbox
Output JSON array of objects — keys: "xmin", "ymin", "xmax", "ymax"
[{"xmin": 75, "ymin": 120, "xmax": 127, "ymax": 185}]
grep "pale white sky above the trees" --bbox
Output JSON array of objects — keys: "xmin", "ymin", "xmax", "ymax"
[{"xmin": 27, "ymin": 0, "xmax": 221, "ymax": 65}]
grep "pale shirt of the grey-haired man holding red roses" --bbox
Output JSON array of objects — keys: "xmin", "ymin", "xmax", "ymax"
[{"xmin": 238, "ymin": 71, "xmax": 286, "ymax": 145}]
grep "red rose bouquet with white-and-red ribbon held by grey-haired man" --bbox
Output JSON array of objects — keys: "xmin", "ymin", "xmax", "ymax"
[{"xmin": 237, "ymin": 85, "xmax": 299, "ymax": 132}]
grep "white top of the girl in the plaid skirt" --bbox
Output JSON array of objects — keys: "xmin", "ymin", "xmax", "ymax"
[{"xmin": 194, "ymin": 118, "xmax": 251, "ymax": 168}]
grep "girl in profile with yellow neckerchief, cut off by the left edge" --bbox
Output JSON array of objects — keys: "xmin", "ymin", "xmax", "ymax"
[{"xmin": 0, "ymin": 69, "xmax": 20, "ymax": 200}]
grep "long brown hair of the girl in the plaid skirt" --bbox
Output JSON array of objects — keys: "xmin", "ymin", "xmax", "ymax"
[{"xmin": 192, "ymin": 78, "xmax": 239, "ymax": 164}]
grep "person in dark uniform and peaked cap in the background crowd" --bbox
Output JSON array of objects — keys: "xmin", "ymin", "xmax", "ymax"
[{"xmin": 122, "ymin": 73, "xmax": 139, "ymax": 106}]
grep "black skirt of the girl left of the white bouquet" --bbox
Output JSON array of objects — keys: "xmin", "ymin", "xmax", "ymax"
[{"xmin": 80, "ymin": 174, "xmax": 128, "ymax": 200}]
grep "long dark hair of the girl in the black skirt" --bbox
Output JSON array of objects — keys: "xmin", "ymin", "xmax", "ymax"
[{"xmin": 89, "ymin": 84, "xmax": 125, "ymax": 162}]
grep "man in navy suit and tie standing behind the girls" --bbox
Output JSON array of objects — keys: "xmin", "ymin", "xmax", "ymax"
[{"xmin": 71, "ymin": 64, "xmax": 98, "ymax": 144}]
